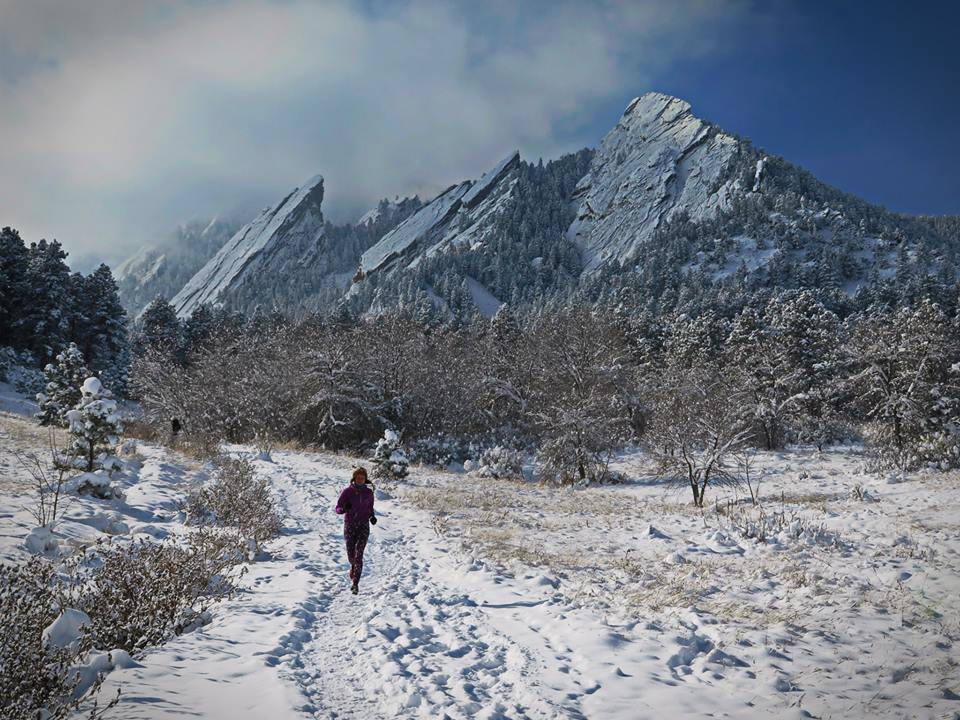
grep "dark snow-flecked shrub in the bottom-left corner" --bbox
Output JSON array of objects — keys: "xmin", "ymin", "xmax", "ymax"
[{"xmin": 0, "ymin": 557, "xmax": 116, "ymax": 720}]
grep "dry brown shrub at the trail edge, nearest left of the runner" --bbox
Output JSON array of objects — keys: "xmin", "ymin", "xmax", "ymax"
[{"xmin": 184, "ymin": 456, "xmax": 283, "ymax": 559}]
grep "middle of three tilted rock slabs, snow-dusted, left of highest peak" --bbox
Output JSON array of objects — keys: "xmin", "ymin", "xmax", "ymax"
[{"xmin": 360, "ymin": 152, "xmax": 520, "ymax": 275}]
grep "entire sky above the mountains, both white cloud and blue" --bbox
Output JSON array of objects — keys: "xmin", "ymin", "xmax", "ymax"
[{"xmin": 0, "ymin": 0, "xmax": 960, "ymax": 265}]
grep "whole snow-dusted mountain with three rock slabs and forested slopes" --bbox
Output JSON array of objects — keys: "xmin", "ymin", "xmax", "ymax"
[{"xmin": 122, "ymin": 93, "xmax": 960, "ymax": 317}]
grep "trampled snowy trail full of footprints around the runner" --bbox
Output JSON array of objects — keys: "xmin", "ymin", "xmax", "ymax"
[{"xmin": 263, "ymin": 456, "xmax": 568, "ymax": 718}]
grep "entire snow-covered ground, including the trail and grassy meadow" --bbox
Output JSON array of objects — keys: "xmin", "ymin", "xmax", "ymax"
[{"xmin": 0, "ymin": 402, "xmax": 960, "ymax": 720}]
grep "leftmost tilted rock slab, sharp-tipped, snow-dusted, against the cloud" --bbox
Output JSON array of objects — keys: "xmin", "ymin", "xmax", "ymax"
[{"xmin": 170, "ymin": 175, "xmax": 324, "ymax": 318}]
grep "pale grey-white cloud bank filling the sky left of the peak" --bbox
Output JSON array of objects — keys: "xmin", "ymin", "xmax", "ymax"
[{"xmin": 0, "ymin": 0, "xmax": 745, "ymax": 260}]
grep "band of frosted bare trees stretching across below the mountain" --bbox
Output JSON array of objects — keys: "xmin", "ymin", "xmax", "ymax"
[{"xmin": 132, "ymin": 290, "xmax": 960, "ymax": 501}]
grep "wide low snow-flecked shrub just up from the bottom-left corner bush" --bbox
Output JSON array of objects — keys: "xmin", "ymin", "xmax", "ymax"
[{"xmin": 66, "ymin": 531, "xmax": 239, "ymax": 654}]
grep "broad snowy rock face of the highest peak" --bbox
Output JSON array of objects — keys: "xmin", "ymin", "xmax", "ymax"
[{"xmin": 568, "ymin": 93, "xmax": 740, "ymax": 273}]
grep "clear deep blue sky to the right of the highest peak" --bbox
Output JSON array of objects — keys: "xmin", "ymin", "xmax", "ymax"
[{"xmin": 628, "ymin": 0, "xmax": 960, "ymax": 214}]
